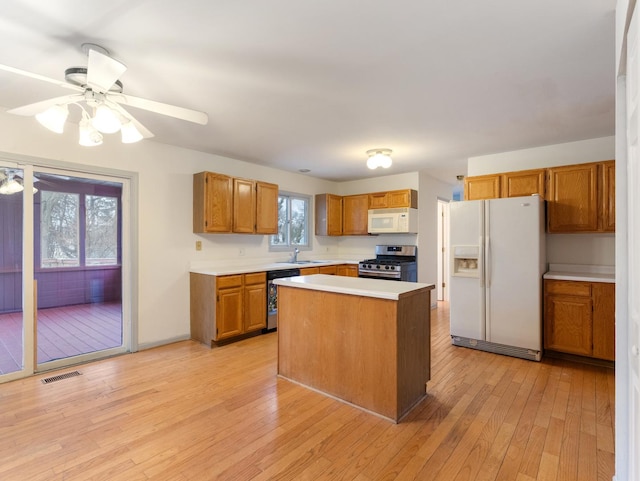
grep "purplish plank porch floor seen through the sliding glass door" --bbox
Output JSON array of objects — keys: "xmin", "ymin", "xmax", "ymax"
[{"xmin": 0, "ymin": 302, "xmax": 122, "ymax": 374}]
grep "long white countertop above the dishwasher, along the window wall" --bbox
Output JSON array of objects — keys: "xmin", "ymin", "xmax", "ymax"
[{"xmin": 189, "ymin": 259, "xmax": 362, "ymax": 276}]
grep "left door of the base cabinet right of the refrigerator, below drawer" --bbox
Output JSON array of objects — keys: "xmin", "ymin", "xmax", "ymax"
[{"xmin": 544, "ymin": 295, "xmax": 593, "ymax": 356}]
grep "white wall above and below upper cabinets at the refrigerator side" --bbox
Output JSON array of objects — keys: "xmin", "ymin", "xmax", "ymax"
[{"xmin": 467, "ymin": 137, "xmax": 615, "ymax": 266}]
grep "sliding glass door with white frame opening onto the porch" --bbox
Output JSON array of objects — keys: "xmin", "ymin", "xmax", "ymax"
[{"xmin": 0, "ymin": 164, "xmax": 131, "ymax": 381}]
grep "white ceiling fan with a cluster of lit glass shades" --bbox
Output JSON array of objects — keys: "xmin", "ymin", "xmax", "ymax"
[{"xmin": 0, "ymin": 43, "xmax": 209, "ymax": 146}]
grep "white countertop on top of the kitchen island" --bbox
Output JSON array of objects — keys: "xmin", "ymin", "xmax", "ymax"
[{"xmin": 273, "ymin": 274, "xmax": 435, "ymax": 301}]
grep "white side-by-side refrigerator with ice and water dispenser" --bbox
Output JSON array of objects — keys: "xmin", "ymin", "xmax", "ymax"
[{"xmin": 449, "ymin": 195, "xmax": 546, "ymax": 361}]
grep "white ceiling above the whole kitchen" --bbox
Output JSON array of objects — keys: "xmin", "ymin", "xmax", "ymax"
[{"xmin": 0, "ymin": 0, "xmax": 616, "ymax": 183}]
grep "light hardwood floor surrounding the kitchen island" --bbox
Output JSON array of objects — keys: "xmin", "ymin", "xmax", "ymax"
[{"xmin": 0, "ymin": 304, "xmax": 614, "ymax": 481}]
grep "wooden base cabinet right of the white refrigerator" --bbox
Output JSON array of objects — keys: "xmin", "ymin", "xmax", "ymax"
[{"xmin": 544, "ymin": 280, "xmax": 615, "ymax": 361}]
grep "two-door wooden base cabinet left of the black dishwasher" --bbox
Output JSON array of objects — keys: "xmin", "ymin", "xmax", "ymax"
[{"xmin": 190, "ymin": 272, "xmax": 267, "ymax": 346}]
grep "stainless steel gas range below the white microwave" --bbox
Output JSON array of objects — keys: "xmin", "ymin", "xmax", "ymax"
[{"xmin": 358, "ymin": 245, "xmax": 418, "ymax": 282}]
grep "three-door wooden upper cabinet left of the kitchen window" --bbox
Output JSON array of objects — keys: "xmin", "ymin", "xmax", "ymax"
[{"xmin": 193, "ymin": 172, "xmax": 278, "ymax": 234}]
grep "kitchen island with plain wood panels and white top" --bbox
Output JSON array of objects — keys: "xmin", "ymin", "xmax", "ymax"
[{"xmin": 274, "ymin": 274, "xmax": 434, "ymax": 422}]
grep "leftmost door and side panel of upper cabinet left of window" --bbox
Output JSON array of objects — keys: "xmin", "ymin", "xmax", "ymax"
[{"xmin": 193, "ymin": 172, "xmax": 233, "ymax": 233}]
